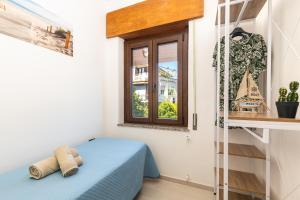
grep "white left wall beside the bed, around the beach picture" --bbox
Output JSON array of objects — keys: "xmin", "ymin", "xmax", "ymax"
[{"xmin": 0, "ymin": 0, "xmax": 106, "ymax": 173}]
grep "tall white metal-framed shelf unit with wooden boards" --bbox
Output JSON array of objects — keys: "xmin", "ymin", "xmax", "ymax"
[{"xmin": 214, "ymin": 0, "xmax": 274, "ymax": 200}]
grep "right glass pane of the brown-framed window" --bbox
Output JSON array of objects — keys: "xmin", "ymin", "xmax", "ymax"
[{"xmin": 158, "ymin": 42, "xmax": 178, "ymax": 120}]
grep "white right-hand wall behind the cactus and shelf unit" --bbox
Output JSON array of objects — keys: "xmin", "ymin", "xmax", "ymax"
[{"xmin": 256, "ymin": 0, "xmax": 300, "ymax": 200}]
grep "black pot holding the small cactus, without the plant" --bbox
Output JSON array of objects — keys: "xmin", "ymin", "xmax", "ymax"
[{"xmin": 276, "ymin": 102, "xmax": 299, "ymax": 118}]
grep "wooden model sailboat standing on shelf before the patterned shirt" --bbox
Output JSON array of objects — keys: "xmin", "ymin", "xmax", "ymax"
[{"xmin": 235, "ymin": 70, "xmax": 268, "ymax": 112}]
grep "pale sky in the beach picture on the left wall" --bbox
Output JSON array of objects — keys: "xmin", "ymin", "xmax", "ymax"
[{"xmin": 6, "ymin": 0, "xmax": 71, "ymax": 30}]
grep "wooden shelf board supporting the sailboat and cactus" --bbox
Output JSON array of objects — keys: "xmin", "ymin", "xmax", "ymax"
[{"xmin": 228, "ymin": 112, "xmax": 300, "ymax": 123}]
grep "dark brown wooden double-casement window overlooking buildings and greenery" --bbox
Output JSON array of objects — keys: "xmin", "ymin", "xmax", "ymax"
[{"xmin": 124, "ymin": 29, "xmax": 188, "ymax": 126}]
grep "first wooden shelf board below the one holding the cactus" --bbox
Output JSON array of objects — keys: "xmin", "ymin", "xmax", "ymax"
[{"xmin": 219, "ymin": 142, "xmax": 266, "ymax": 160}]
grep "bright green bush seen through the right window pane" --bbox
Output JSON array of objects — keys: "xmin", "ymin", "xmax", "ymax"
[{"xmin": 158, "ymin": 101, "xmax": 177, "ymax": 119}]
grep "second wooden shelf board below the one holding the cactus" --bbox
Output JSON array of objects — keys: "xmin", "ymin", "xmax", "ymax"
[{"xmin": 220, "ymin": 169, "xmax": 265, "ymax": 196}]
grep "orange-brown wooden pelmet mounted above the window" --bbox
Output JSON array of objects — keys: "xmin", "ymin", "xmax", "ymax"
[{"xmin": 106, "ymin": 0, "xmax": 204, "ymax": 38}]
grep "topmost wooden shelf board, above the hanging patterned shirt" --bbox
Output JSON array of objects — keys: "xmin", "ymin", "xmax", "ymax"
[{"xmin": 216, "ymin": 0, "xmax": 266, "ymax": 25}]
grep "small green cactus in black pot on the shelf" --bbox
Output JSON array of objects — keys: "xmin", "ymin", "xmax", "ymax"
[{"xmin": 276, "ymin": 81, "xmax": 299, "ymax": 118}]
